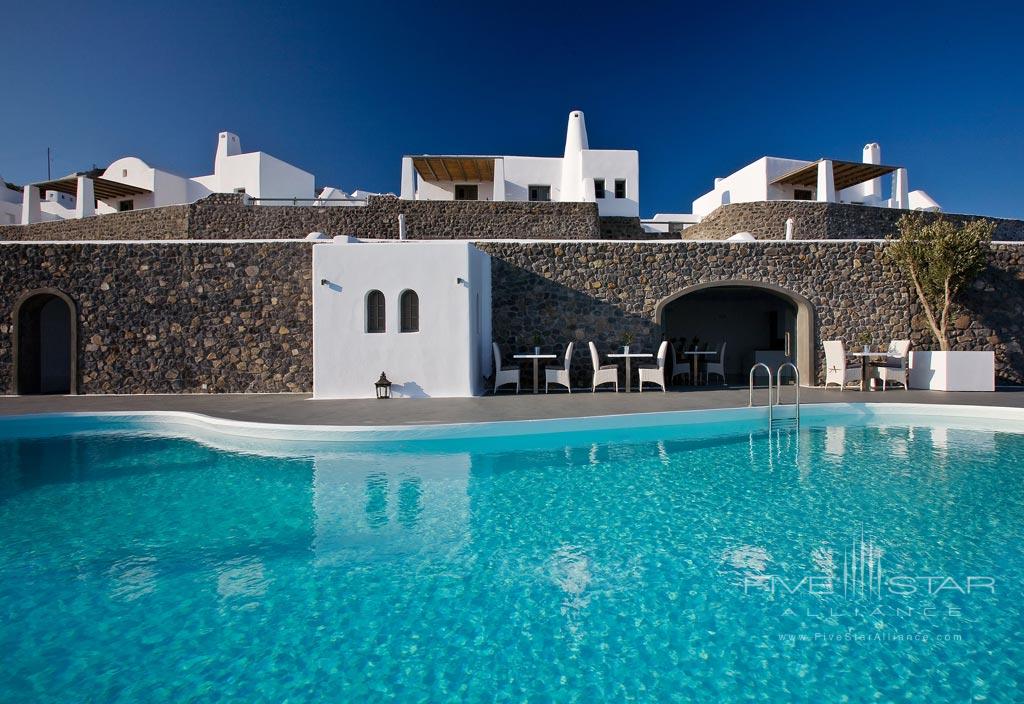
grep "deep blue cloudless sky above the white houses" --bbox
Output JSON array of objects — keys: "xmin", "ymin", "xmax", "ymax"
[{"xmin": 0, "ymin": 1, "xmax": 1024, "ymax": 217}]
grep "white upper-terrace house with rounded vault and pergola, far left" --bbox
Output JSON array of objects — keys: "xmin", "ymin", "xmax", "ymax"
[{"xmin": 20, "ymin": 132, "xmax": 315, "ymax": 224}]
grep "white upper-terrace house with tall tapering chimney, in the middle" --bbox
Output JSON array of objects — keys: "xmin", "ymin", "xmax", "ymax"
[{"xmin": 401, "ymin": 111, "xmax": 640, "ymax": 217}]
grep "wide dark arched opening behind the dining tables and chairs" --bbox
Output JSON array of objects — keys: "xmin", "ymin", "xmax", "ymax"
[{"xmin": 654, "ymin": 279, "xmax": 815, "ymax": 386}]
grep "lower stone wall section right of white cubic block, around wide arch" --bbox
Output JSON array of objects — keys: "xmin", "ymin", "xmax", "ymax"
[{"xmin": 480, "ymin": 241, "xmax": 1024, "ymax": 386}]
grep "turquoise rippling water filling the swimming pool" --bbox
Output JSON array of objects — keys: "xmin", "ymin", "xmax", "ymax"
[{"xmin": 0, "ymin": 415, "xmax": 1024, "ymax": 702}]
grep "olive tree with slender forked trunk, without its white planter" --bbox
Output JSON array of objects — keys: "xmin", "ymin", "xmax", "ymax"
[{"xmin": 886, "ymin": 213, "xmax": 995, "ymax": 352}]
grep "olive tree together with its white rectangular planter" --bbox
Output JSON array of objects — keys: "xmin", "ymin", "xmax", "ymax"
[{"xmin": 886, "ymin": 214, "xmax": 995, "ymax": 391}]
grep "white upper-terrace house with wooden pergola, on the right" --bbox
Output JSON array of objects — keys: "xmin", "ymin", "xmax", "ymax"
[{"xmin": 684, "ymin": 143, "xmax": 940, "ymax": 219}]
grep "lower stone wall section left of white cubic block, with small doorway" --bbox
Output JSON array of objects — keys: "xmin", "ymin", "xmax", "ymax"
[{"xmin": 0, "ymin": 243, "xmax": 312, "ymax": 394}]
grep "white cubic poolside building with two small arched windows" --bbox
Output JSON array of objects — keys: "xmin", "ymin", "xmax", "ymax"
[{"xmin": 312, "ymin": 237, "xmax": 492, "ymax": 398}]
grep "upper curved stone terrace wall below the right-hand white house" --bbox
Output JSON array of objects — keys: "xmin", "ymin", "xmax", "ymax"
[{"xmin": 683, "ymin": 201, "xmax": 1024, "ymax": 241}]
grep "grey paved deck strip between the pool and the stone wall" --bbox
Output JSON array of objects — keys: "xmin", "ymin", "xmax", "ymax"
[{"xmin": 0, "ymin": 387, "xmax": 1024, "ymax": 426}]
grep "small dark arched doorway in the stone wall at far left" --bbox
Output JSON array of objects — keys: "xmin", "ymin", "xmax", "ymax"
[{"xmin": 13, "ymin": 289, "xmax": 78, "ymax": 394}]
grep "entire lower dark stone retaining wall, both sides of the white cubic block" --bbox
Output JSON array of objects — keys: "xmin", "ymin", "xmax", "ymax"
[{"xmin": 0, "ymin": 241, "xmax": 1024, "ymax": 393}]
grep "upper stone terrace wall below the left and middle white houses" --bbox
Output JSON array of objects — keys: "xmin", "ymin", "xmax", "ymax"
[{"xmin": 0, "ymin": 193, "xmax": 601, "ymax": 240}]
